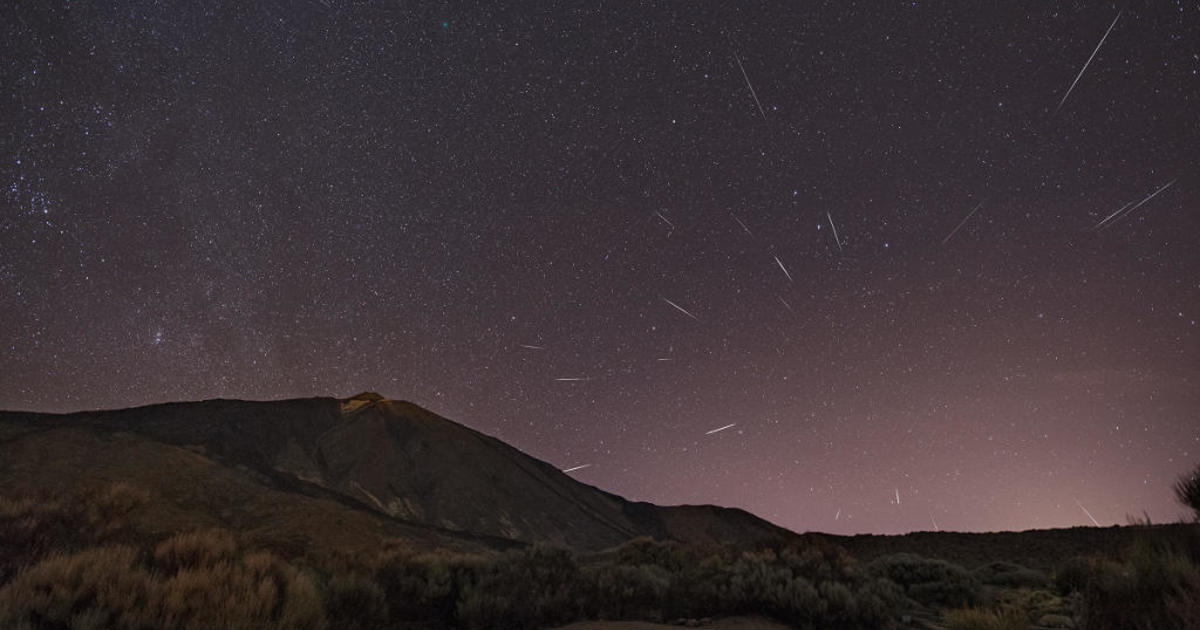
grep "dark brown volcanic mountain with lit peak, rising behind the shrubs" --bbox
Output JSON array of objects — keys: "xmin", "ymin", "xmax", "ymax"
[{"xmin": 0, "ymin": 392, "xmax": 796, "ymax": 551}]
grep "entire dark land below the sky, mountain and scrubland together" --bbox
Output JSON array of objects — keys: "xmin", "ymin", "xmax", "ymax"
[{"xmin": 0, "ymin": 394, "xmax": 1200, "ymax": 630}]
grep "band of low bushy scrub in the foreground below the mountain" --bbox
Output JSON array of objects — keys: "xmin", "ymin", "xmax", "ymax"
[{"xmin": 0, "ymin": 484, "xmax": 1200, "ymax": 630}]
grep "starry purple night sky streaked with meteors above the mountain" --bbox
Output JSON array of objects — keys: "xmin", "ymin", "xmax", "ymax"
[{"xmin": 0, "ymin": 0, "xmax": 1200, "ymax": 533}]
